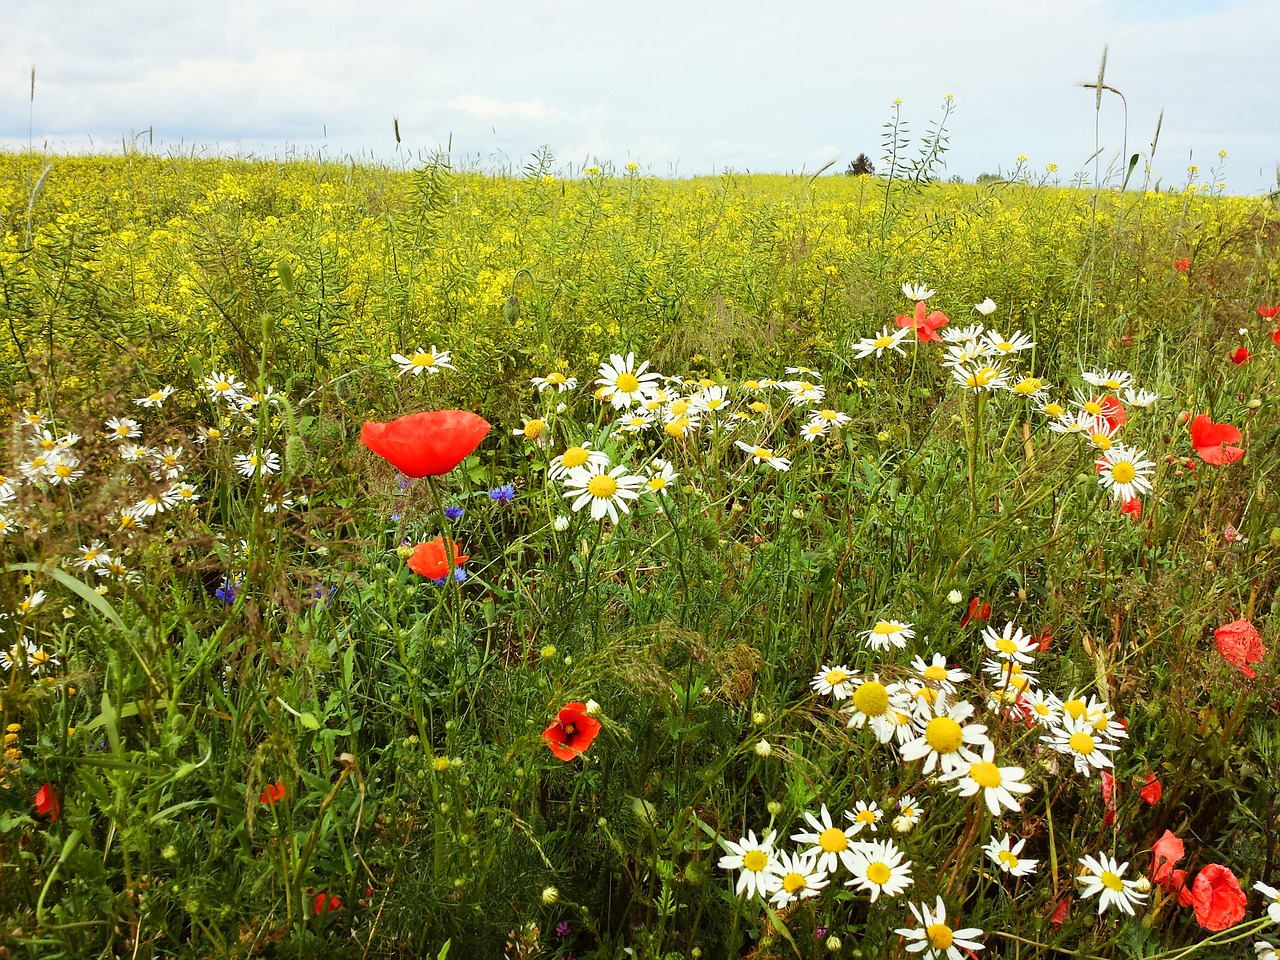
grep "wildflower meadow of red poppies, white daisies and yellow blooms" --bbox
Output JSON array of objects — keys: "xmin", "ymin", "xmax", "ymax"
[{"xmin": 0, "ymin": 131, "xmax": 1280, "ymax": 960}]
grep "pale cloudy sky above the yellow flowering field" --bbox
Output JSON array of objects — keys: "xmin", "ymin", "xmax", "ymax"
[{"xmin": 0, "ymin": 0, "xmax": 1280, "ymax": 195}]
